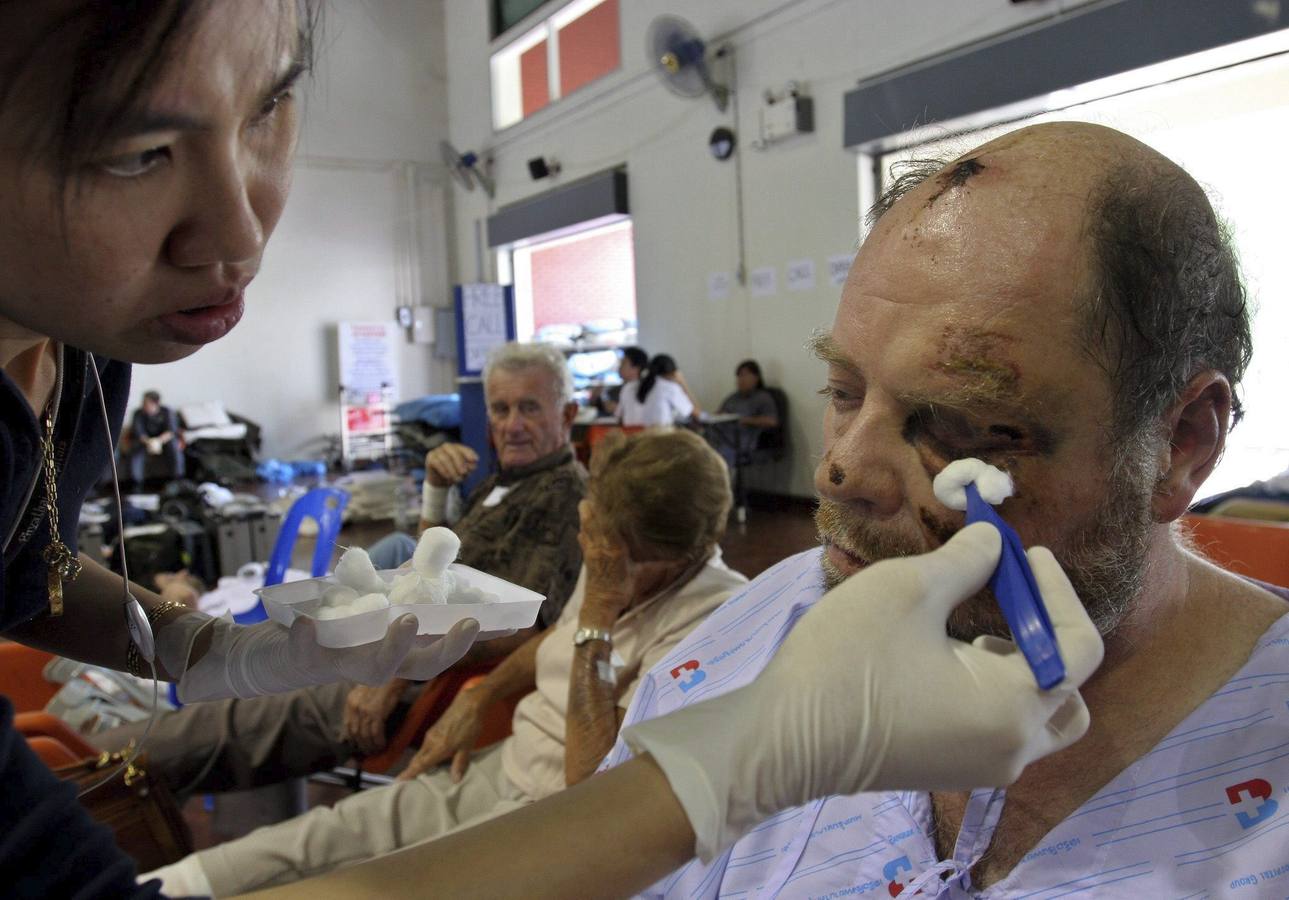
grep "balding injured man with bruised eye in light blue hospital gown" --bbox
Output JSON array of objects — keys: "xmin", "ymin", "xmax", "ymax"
[{"xmin": 605, "ymin": 124, "xmax": 1289, "ymax": 899}]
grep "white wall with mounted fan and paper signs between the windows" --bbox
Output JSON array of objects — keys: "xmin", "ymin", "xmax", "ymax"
[{"xmin": 446, "ymin": 0, "xmax": 1098, "ymax": 496}]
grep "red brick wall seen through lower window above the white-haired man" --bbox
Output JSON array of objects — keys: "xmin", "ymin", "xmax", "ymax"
[{"xmin": 532, "ymin": 228, "xmax": 635, "ymax": 328}]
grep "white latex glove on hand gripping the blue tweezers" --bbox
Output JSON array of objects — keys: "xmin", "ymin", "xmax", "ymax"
[{"xmin": 624, "ymin": 522, "xmax": 1103, "ymax": 861}]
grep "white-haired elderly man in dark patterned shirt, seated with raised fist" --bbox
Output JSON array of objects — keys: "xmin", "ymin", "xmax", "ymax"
[{"xmin": 93, "ymin": 343, "xmax": 586, "ymax": 792}]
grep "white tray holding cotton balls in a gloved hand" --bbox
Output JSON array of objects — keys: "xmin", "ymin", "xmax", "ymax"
[{"xmin": 255, "ymin": 563, "xmax": 545, "ymax": 647}]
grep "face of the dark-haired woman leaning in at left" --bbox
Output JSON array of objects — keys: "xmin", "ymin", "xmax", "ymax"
[{"xmin": 0, "ymin": 0, "xmax": 302, "ymax": 362}]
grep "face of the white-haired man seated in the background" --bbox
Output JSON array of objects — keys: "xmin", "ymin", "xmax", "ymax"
[{"xmin": 485, "ymin": 366, "xmax": 576, "ymax": 468}]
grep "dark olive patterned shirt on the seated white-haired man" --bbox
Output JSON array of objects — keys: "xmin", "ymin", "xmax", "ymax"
[{"xmin": 452, "ymin": 447, "xmax": 586, "ymax": 628}]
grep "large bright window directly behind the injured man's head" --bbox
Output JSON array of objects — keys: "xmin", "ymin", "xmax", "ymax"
[{"xmin": 860, "ymin": 53, "xmax": 1289, "ymax": 496}]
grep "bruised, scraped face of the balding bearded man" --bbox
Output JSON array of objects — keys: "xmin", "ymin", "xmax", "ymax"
[{"xmin": 816, "ymin": 145, "xmax": 1165, "ymax": 640}]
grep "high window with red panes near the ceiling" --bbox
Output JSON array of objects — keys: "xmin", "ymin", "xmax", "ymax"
[{"xmin": 492, "ymin": 0, "xmax": 621, "ymax": 130}]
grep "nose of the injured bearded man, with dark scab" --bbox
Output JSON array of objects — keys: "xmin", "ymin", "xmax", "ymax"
[{"xmin": 815, "ymin": 409, "xmax": 905, "ymax": 518}]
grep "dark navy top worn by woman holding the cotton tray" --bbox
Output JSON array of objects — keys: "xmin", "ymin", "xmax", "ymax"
[{"xmin": 0, "ymin": 348, "xmax": 160, "ymax": 897}]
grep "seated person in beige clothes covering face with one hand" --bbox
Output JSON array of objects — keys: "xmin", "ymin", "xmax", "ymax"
[{"xmin": 153, "ymin": 431, "xmax": 748, "ymax": 897}]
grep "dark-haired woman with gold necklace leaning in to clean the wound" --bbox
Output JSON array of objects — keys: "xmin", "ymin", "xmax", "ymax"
[{"xmin": 0, "ymin": 0, "xmax": 477, "ymax": 897}]
